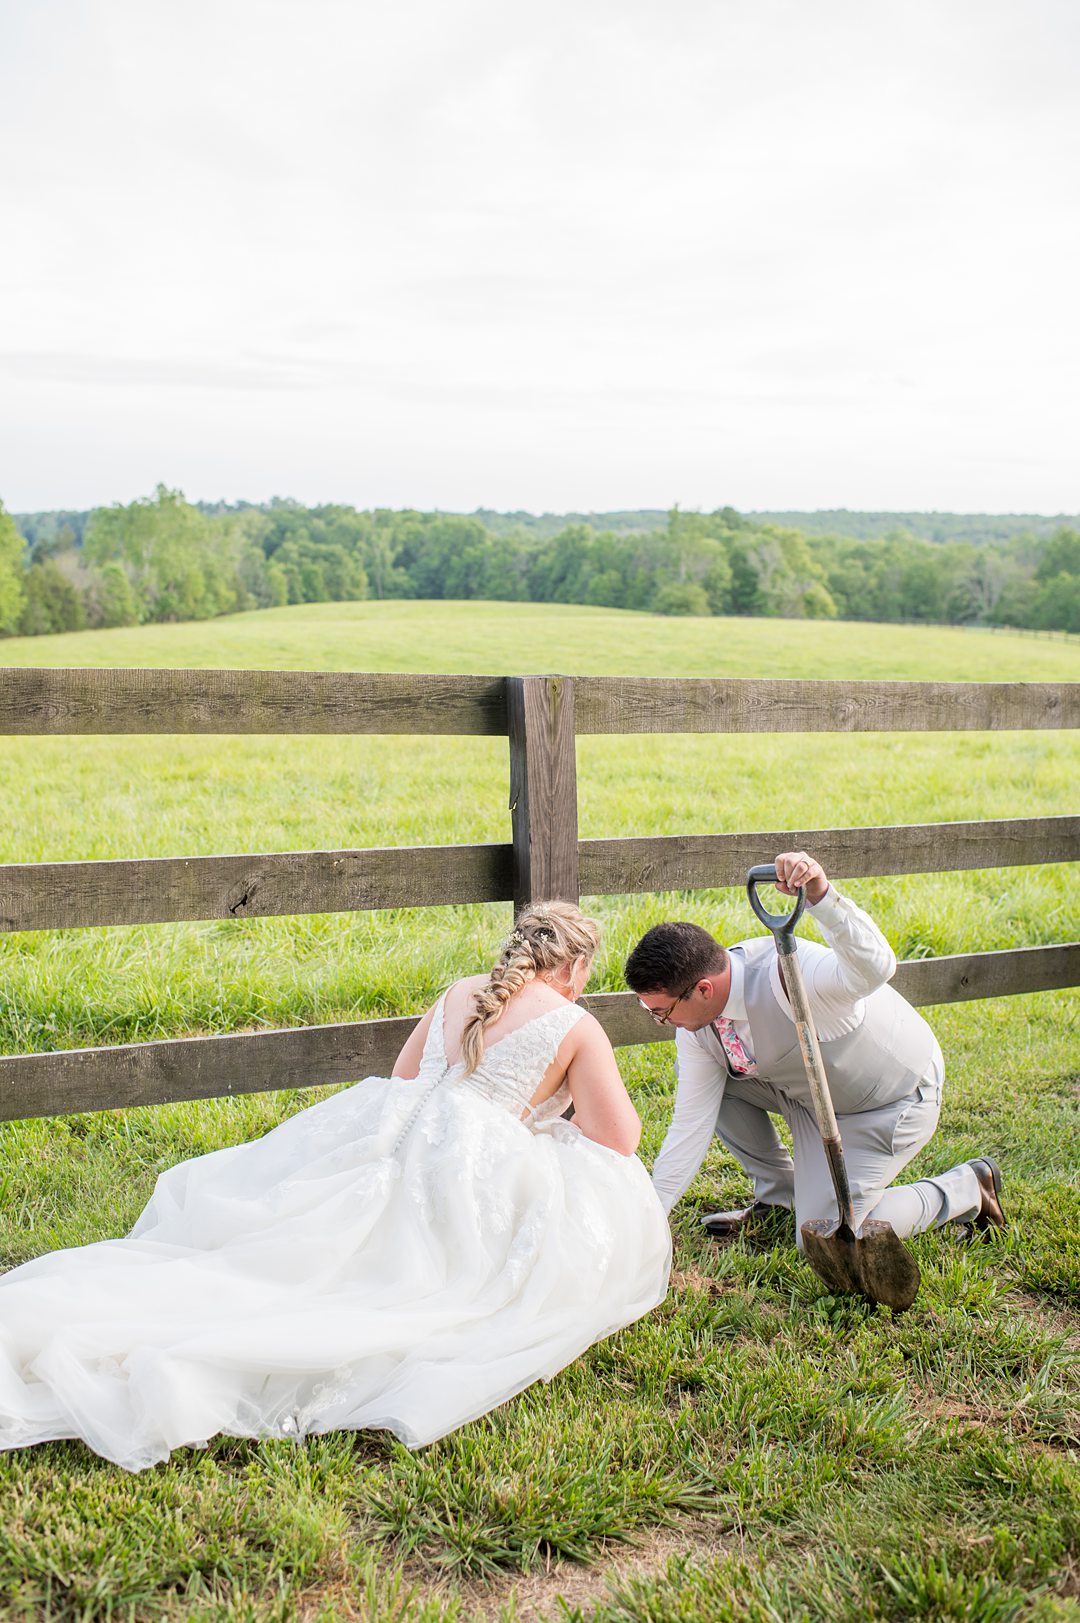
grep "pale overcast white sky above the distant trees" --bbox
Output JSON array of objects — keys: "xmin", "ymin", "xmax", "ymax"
[{"xmin": 0, "ymin": 0, "xmax": 1080, "ymax": 513}]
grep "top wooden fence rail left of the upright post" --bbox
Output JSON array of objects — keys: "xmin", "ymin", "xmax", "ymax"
[{"xmin": 0, "ymin": 667, "xmax": 507, "ymax": 734}]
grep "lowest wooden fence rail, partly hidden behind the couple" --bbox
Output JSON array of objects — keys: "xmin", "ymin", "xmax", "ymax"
[{"xmin": 0, "ymin": 941, "xmax": 1080, "ymax": 1121}]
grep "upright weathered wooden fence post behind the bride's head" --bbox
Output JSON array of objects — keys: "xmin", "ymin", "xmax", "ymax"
[{"xmin": 507, "ymin": 677, "xmax": 580, "ymax": 911}]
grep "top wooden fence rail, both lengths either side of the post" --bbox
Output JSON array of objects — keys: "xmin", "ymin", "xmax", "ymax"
[{"xmin": 0, "ymin": 667, "xmax": 1080, "ymax": 737}]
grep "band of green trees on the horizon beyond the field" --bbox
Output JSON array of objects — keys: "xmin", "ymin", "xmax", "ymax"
[{"xmin": 0, "ymin": 485, "xmax": 1080, "ymax": 636}]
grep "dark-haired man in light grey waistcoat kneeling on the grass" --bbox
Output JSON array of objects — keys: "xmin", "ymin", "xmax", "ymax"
[{"xmin": 625, "ymin": 850, "xmax": 1005, "ymax": 1243}]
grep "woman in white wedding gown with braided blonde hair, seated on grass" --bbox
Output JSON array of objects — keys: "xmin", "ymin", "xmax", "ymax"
[{"xmin": 0, "ymin": 902, "xmax": 671, "ymax": 1470}]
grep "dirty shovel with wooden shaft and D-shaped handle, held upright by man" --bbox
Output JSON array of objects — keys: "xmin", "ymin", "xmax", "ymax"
[{"xmin": 747, "ymin": 862, "xmax": 919, "ymax": 1313}]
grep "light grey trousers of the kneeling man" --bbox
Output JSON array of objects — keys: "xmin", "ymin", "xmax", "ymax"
[{"xmin": 716, "ymin": 1058, "xmax": 981, "ymax": 1246}]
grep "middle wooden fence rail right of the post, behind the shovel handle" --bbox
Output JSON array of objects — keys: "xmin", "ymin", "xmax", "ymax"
[{"xmin": 581, "ymin": 816, "xmax": 1080, "ymax": 896}]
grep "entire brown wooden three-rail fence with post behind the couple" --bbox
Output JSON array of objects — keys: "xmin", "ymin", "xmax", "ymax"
[{"xmin": 0, "ymin": 669, "xmax": 1080, "ymax": 1120}]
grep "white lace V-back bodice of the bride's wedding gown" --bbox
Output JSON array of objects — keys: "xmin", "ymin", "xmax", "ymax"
[{"xmin": 421, "ymin": 992, "xmax": 585, "ymax": 1125}]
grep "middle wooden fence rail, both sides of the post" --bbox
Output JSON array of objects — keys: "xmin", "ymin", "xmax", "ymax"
[{"xmin": 0, "ymin": 816, "xmax": 1080, "ymax": 933}]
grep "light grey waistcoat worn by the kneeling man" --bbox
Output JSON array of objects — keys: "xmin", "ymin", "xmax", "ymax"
[{"xmin": 693, "ymin": 936, "xmax": 935, "ymax": 1115}]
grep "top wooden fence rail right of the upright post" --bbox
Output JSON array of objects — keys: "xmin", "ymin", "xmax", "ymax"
[{"xmin": 575, "ymin": 677, "xmax": 1080, "ymax": 734}]
